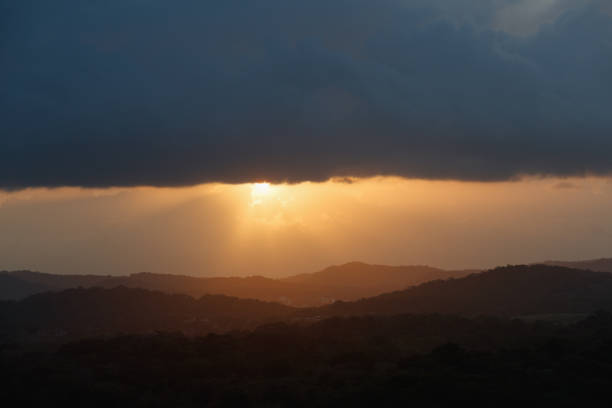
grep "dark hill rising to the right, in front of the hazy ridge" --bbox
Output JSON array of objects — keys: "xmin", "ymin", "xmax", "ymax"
[{"xmin": 300, "ymin": 265, "xmax": 612, "ymax": 316}]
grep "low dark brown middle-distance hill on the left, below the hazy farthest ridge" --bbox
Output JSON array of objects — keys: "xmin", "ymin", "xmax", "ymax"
[{"xmin": 0, "ymin": 287, "xmax": 294, "ymax": 340}]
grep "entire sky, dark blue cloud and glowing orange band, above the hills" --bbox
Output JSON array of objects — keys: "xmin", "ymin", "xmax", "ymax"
[{"xmin": 0, "ymin": 0, "xmax": 612, "ymax": 276}]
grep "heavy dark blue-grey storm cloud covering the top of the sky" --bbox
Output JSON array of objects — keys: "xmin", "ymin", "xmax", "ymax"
[{"xmin": 0, "ymin": 0, "xmax": 612, "ymax": 189}]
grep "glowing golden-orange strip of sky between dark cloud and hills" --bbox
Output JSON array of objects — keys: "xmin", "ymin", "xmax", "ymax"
[{"xmin": 0, "ymin": 178, "xmax": 612, "ymax": 276}]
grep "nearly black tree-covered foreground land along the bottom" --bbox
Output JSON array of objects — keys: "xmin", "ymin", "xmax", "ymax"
[{"xmin": 0, "ymin": 312, "xmax": 612, "ymax": 407}]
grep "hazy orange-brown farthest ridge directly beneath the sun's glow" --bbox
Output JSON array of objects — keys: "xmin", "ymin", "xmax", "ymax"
[{"xmin": 0, "ymin": 262, "xmax": 470, "ymax": 306}]
